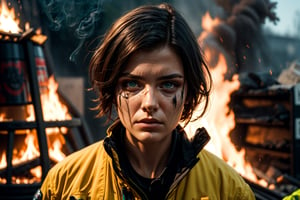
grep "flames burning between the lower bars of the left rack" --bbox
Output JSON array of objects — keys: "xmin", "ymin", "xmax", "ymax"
[{"xmin": 0, "ymin": 76, "xmax": 71, "ymax": 184}]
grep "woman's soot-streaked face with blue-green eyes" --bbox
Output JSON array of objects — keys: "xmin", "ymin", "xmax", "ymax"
[{"xmin": 116, "ymin": 47, "xmax": 187, "ymax": 143}]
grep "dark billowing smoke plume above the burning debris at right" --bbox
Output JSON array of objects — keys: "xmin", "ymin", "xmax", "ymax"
[{"xmin": 200, "ymin": 0, "xmax": 279, "ymax": 77}]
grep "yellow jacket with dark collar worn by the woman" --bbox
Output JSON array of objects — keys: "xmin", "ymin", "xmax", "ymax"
[{"xmin": 41, "ymin": 123, "xmax": 255, "ymax": 200}]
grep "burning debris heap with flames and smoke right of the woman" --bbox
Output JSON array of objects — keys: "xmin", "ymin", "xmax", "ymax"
[{"xmin": 186, "ymin": 0, "xmax": 300, "ymax": 199}]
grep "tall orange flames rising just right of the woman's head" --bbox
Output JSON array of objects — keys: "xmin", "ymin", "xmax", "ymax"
[{"xmin": 185, "ymin": 13, "xmax": 267, "ymax": 187}]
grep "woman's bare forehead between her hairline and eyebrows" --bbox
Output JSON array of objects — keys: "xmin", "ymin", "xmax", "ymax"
[{"xmin": 123, "ymin": 46, "xmax": 184, "ymax": 76}]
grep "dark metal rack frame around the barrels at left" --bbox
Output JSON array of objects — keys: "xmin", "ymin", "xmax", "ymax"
[{"xmin": 0, "ymin": 36, "xmax": 92, "ymax": 199}]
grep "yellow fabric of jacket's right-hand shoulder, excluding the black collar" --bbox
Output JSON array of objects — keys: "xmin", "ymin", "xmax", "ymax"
[{"xmin": 176, "ymin": 149, "xmax": 255, "ymax": 199}]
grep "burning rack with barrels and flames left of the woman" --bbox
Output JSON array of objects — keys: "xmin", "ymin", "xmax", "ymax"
[{"xmin": 0, "ymin": 1, "xmax": 91, "ymax": 199}]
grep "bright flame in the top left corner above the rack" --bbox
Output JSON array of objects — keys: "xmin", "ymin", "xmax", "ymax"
[{"xmin": 0, "ymin": 0, "xmax": 22, "ymax": 33}]
